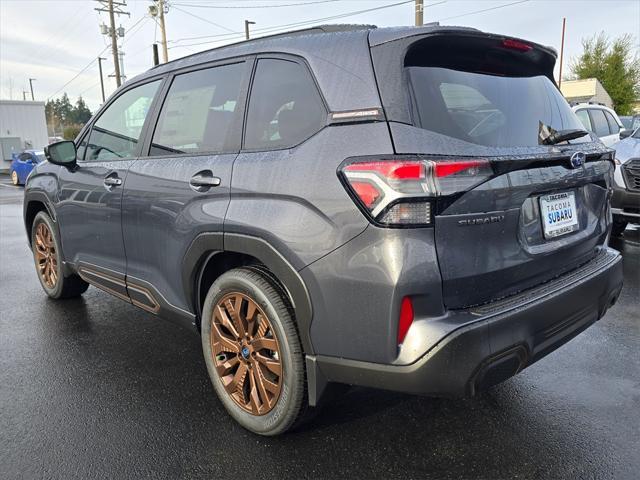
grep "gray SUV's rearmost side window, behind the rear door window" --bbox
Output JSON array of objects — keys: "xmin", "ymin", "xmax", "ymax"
[{"xmin": 244, "ymin": 58, "xmax": 327, "ymax": 150}]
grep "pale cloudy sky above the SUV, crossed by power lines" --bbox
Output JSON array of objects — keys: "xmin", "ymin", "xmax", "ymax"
[{"xmin": 0, "ymin": 0, "xmax": 640, "ymax": 110}]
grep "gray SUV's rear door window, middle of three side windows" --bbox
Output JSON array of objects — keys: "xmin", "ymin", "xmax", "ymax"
[{"xmin": 149, "ymin": 63, "xmax": 245, "ymax": 156}]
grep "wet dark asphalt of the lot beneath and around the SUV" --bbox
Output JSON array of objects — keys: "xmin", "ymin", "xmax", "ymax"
[{"xmin": 0, "ymin": 177, "xmax": 640, "ymax": 480}]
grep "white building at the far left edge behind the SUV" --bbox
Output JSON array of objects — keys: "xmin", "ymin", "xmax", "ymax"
[{"xmin": 0, "ymin": 100, "xmax": 48, "ymax": 170}]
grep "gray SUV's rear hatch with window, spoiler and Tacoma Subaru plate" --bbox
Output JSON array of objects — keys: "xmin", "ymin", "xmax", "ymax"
[{"xmin": 370, "ymin": 29, "xmax": 613, "ymax": 308}]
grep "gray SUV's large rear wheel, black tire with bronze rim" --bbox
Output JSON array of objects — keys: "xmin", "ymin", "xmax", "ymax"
[{"xmin": 201, "ymin": 267, "xmax": 308, "ymax": 436}]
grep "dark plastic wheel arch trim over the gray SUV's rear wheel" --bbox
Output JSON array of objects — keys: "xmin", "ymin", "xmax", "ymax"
[{"xmin": 182, "ymin": 233, "xmax": 313, "ymax": 354}]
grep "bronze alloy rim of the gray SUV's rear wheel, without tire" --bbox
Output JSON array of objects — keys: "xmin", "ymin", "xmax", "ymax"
[{"xmin": 210, "ymin": 292, "xmax": 283, "ymax": 415}]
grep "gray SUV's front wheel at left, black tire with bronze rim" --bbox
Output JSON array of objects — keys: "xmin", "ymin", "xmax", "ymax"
[{"xmin": 31, "ymin": 212, "xmax": 89, "ymax": 299}]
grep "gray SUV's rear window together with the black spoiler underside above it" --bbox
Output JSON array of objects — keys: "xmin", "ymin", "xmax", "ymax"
[{"xmin": 404, "ymin": 35, "xmax": 591, "ymax": 147}]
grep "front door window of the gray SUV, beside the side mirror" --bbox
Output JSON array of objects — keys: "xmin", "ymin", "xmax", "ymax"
[{"xmin": 85, "ymin": 80, "xmax": 160, "ymax": 160}]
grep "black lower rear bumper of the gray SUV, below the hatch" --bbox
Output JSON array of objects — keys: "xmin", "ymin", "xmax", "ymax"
[{"xmin": 307, "ymin": 248, "xmax": 622, "ymax": 405}]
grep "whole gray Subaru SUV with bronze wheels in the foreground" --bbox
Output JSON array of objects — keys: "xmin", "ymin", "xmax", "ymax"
[{"xmin": 24, "ymin": 25, "xmax": 622, "ymax": 435}]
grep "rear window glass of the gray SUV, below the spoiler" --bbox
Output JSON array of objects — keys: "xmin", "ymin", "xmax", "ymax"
[{"xmin": 406, "ymin": 67, "xmax": 590, "ymax": 147}]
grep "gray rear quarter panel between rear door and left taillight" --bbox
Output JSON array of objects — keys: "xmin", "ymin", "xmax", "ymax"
[{"xmin": 225, "ymin": 122, "xmax": 393, "ymax": 270}]
